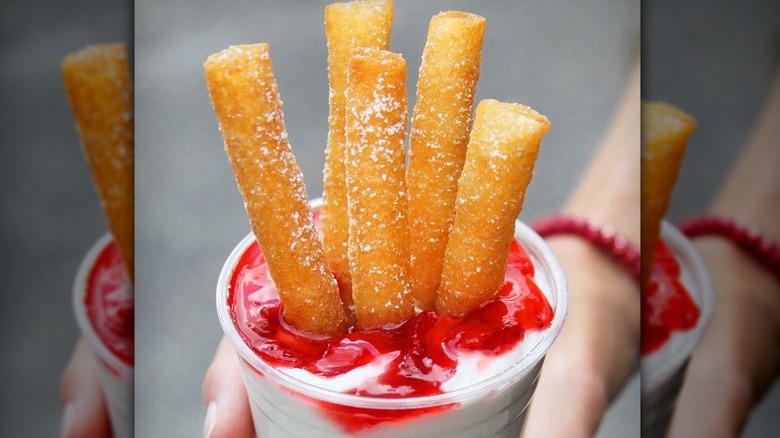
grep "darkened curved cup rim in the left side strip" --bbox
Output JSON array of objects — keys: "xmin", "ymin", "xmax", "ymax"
[{"xmin": 73, "ymin": 232, "xmax": 134, "ymax": 376}]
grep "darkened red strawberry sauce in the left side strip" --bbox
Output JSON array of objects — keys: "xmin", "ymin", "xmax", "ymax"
[{"xmin": 84, "ymin": 240, "xmax": 135, "ymax": 366}]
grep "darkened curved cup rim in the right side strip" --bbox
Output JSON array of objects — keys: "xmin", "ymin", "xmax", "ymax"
[{"xmin": 641, "ymin": 220, "xmax": 715, "ymax": 392}]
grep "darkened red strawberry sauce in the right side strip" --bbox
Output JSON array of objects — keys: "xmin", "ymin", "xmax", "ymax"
[{"xmin": 642, "ymin": 240, "xmax": 700, "ymax": 356}]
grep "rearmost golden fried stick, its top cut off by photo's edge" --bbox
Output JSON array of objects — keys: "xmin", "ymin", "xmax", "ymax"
[{"xmin": 321, "ymin": 0, "xmax": 393, "ymax": 306}]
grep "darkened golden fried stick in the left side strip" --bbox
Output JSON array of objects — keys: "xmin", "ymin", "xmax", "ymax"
[{"xmin": 62, "ymin": 43, "xmax": 135, "ymax": 278}]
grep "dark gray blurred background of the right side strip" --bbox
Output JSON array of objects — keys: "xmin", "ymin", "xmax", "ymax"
[{"xmin": 642, "ymin": 0, "xmax": 780, "ymax": 437}]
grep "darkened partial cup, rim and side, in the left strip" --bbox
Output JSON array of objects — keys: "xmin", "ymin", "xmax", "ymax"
[{"xmin": 73, "ymin": 233, "xmax": 133, "ymax": 438}]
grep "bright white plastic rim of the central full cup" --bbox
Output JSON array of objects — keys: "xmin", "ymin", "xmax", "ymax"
[{"xmin": 216, "ymin": 198, "xmax": 568, "ymax": 409}]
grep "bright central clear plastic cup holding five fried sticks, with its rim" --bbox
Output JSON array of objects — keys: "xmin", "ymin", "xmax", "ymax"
[{"xmin": 217, "ymin": 200, "xmax": 567, "ymax": 438}]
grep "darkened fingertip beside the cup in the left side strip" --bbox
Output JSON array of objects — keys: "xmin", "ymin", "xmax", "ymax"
[{"xmin": 60, "ymin": 339, "xmax": 112, "ymax": 438}]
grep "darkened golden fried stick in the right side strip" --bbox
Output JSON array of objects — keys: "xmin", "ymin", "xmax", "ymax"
[{"xmin": 641, "ymin": 102, "xmax": 696, "ymax": 287}]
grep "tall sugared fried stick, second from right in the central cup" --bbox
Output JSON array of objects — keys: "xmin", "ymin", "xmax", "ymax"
[{"xmin": 406, "ymin": 11, "xmax": 485, "ymax": 309}]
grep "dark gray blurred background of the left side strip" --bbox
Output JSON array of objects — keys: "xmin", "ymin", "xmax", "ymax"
[{"xmin": 0, "ymin": 0, "xmax": 132, "ymax": 437}]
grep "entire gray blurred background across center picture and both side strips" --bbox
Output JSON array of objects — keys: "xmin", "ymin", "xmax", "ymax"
[{"xmin": 0, "ymin": 0, "xmax": 780, "ymax": 437}]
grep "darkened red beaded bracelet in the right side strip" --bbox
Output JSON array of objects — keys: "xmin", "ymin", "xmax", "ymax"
[{"xmin": 679, "ymin": 215, "xmax": 780, "ymax": 280}]
